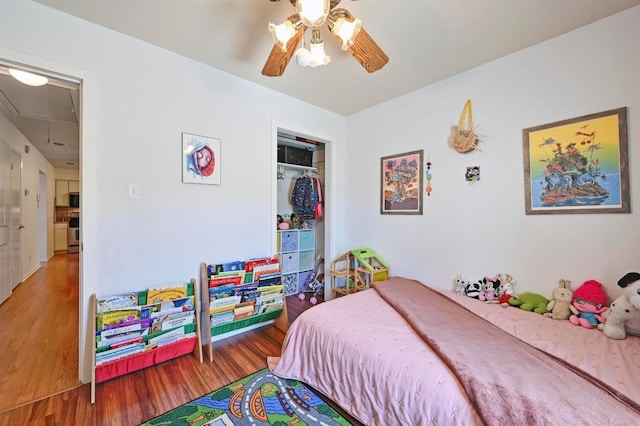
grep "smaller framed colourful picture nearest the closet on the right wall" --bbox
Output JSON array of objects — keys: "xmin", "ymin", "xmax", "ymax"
[{"xmin": 380, "ymin": 150, "xmax": 423, "ymax": 214}]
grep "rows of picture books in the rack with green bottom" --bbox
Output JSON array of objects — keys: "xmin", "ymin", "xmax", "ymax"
[{"xmin": 207, "ymin": 257, "xmax": 284, "ymax": 327}]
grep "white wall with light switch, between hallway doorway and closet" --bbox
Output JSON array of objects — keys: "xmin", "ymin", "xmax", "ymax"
[{"xmin": 0, "ymin": 0, "xmax": 345, "ymax": 380}]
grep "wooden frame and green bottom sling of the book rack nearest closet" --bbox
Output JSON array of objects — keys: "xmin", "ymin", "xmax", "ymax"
[{"xmin": 200, "ymin": 263, "xmax": 289, "ymax": 361}]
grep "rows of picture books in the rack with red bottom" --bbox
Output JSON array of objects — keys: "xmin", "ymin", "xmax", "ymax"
[{"xmin": 95, "ymin": 283, "xmax": 197, "ymax": 366}]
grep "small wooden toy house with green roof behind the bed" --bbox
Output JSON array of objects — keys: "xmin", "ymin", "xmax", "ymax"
[{"xmin": 329, "ymin": 248, "xmax": 389, "ymax": 297}]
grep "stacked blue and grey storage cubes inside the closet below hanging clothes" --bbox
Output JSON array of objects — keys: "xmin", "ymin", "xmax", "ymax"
[{"xmin": 277, "ymin": 229, "xmax": 316, "ymax": 296}]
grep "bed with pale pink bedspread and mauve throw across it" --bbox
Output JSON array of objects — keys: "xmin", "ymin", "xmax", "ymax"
[{"xmin": 268, "ymin": 277, "xmax": 640, "ymax": 425}]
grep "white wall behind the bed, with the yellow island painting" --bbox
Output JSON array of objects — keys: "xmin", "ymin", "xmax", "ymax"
[{"xmin": 346, "ymin": 6, "xmax": 640, "ymax": 297}]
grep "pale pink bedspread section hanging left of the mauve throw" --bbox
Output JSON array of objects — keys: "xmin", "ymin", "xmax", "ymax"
[{"xmin": 268, "ymin": 282, "xmax": 481, "ymax": 426}]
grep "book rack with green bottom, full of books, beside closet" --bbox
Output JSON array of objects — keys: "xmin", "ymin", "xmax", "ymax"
[{"xmin": 200, "ymin": 256, "xmax": 289, "ymax": 361}]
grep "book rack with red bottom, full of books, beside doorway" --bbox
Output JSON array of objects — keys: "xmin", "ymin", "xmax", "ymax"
[{"xmin": 91, "ymin": 279, "xmax": 202, "ymax": 403}]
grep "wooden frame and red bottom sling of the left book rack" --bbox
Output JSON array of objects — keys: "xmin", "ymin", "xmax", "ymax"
[{"xmin": 91, "ymin": 279, "xmax": 203, "ymax": 404}]
